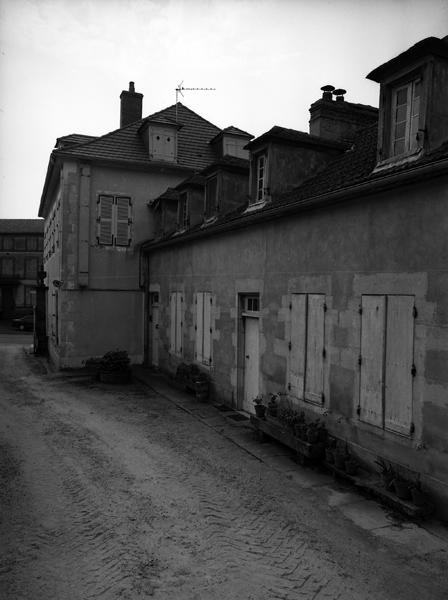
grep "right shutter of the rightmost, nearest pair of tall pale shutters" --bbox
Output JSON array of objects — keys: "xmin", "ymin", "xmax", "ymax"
[{"xmin": 384, "ymin": 296, "xmax": 414, "ymax": 435}]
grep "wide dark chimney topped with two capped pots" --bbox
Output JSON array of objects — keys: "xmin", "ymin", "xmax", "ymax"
[{"xmin": 310, "ymin": 85, "xmax": 378, "ymax": 142}]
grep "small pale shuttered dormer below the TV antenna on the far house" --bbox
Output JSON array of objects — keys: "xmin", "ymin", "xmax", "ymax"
[{"xmin": 140, "ymin": 116, "xmax": 182, "ymax": 163}]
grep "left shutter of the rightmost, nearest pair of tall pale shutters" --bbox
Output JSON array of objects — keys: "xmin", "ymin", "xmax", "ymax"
[{"xmin": 359, "ymin": 296, "xmax": 386, "ymax": 427}]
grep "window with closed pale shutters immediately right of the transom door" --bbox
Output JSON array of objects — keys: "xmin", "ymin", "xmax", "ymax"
[{"xmin": 288, "ymin": 294, "xmax": 326, "ymax": 404}]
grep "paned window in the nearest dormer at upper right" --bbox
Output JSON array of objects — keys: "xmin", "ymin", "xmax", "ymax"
[{"xmin": 391, "ymin": 79, "xmax": 421, "ymax": 156}]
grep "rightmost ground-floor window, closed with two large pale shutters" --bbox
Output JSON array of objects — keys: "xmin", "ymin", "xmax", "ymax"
[{"xmin": 358, "ymin": 295, "xmax": 416, "ymax": 435}]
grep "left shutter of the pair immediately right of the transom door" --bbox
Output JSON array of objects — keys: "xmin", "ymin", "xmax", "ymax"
[{"xmin": 288, "ymin": 294, "xmax": 306, "ymax": 398}]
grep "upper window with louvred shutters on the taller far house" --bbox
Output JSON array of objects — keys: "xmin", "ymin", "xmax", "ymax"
[{"xmin": 97, "ymin": 195, "xmax": 132, "ymax": 246}]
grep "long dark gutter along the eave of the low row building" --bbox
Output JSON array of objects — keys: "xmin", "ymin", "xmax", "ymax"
[{"xmin": 141, "ymin": 159, "xmax": 448, "ymax": 252}]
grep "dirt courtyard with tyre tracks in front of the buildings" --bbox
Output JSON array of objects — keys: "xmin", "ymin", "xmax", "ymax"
[{"xmin": 0, "ymin": 344, "xmax": 448, "ymax": 600}]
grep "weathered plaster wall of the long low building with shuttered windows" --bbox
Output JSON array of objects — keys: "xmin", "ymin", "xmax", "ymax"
[{"xmin": 149, "ymin": 178, "xmax": 448, "ymax": 512}]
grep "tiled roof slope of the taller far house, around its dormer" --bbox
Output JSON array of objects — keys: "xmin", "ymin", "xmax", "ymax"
[{"xmin": 55, "ymin": 102, "xmax": 220, "ymax": 170}]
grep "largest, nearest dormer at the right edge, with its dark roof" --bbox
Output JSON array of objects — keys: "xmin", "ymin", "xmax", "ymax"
[{"xmin": 367, "ymin": 36, "xmax": 448, "ymax": 170}]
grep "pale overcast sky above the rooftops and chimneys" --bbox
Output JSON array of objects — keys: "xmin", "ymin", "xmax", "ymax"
[{"xmin": 0, "ymin": 0, "xmax": 448, "ymax": 218}]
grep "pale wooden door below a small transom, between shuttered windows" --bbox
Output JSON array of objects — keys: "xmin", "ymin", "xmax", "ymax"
[{"xmin": 243, "ymin": 317, "xmax": 260, "ymax": 413}]
